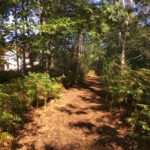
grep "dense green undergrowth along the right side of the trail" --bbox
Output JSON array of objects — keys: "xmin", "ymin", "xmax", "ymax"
[{"xmin": 103, "ymin": 65, "xmax": 150, "ymax": 137}]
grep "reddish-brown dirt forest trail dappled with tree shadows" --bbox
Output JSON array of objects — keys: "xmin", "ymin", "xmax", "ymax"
[{"xmin": 12, "ymin": 77, "xmax": 129, "ymax": 150}]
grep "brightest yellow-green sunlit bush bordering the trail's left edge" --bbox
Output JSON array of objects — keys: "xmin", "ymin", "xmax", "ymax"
[{"xmin": 24, "ymin": 73, "xmax": 61, "ymax": 106}]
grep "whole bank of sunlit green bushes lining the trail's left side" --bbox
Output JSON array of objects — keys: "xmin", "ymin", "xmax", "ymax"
[{"xmin": 0, "ymin": 73, "xmax": 61, "ymax": 144}]
